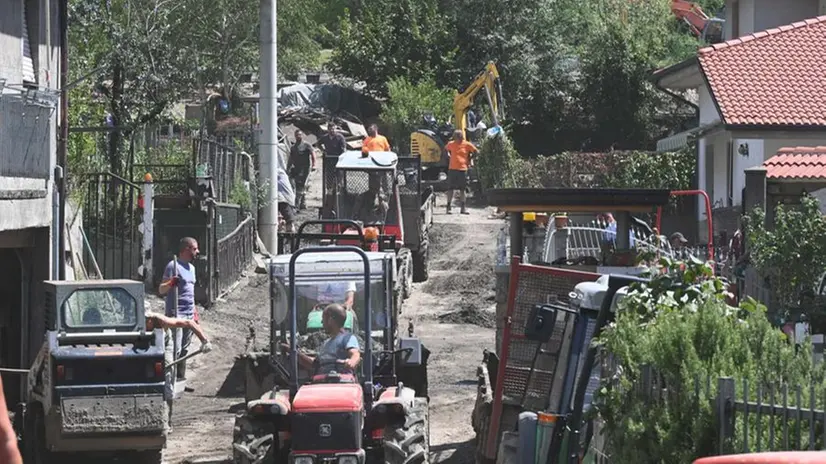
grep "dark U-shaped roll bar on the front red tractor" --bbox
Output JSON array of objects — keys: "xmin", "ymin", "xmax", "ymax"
[{"xmin": 289, "ymin": 245, "xmax": 373, "ymax": 410}]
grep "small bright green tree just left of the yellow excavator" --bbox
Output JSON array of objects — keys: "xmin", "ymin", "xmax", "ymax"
[{"xmin": 381, "ymin": 77, "xmax": 453, "ymax": 152}]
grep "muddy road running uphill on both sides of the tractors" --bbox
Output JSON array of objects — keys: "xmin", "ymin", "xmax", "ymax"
[{"xmin": 158, "ymin": 172, "xmax": 500, "ymax": 464}]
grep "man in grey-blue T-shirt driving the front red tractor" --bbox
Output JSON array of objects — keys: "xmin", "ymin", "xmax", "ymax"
[{"xmin": 281, "ymin": 304, "xmax": 361, "ymax": 374}]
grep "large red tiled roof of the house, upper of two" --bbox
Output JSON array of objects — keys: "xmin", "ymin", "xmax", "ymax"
[{"xmin": 698, "ymin": 16, "xmax": 826, "ymax": 126}]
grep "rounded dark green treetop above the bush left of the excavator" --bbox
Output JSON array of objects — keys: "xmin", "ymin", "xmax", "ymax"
[{"xmin": 331, "ymin": 0, "xmax": 455, "ymax": 95}]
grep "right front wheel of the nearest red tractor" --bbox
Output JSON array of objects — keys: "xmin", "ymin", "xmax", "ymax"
[{"xmin": 384, "ymin": 398, "xmax": 430, "ymax": 464}]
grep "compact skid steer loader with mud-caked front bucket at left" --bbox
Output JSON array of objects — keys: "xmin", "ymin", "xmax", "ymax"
[{"xmin": 22, "ymin": 280, "xmax": 171, "ymax": 463}]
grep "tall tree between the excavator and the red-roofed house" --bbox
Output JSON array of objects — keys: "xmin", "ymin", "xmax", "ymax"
[{"xmin": 579, "ymin": 0, "xmax": 698, "ymax": 150}]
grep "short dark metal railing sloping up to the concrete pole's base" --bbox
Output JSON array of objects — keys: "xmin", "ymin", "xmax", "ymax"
[{"xmin": 215, "ymin": 214, "xmax": 255, "ymax": 295}]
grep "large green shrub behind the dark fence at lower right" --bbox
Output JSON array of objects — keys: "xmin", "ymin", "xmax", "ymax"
[{"xmin": 596, "ymin": 260, "xmax": 823, "ymax": 463}]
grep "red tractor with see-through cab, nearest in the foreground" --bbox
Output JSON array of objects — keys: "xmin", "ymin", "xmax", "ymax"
[{"xmin": 233, "ymin": 246, "xmax": 429, "ymax": 464}]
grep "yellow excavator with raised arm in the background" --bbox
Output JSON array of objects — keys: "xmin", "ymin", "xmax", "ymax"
[{"xmin": 410, "ymin": 61, "xmax": 504, "ymax": 191}]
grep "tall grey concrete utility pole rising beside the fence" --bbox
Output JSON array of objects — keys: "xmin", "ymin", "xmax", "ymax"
[{"xmin": 258, "ymin": 0, "xmax": 278, "ymax": 255}]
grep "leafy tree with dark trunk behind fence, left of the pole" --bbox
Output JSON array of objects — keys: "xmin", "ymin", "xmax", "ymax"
[{"xmin": 69, "ymin": 0, "xmax": 193, "ymax": 173}]
